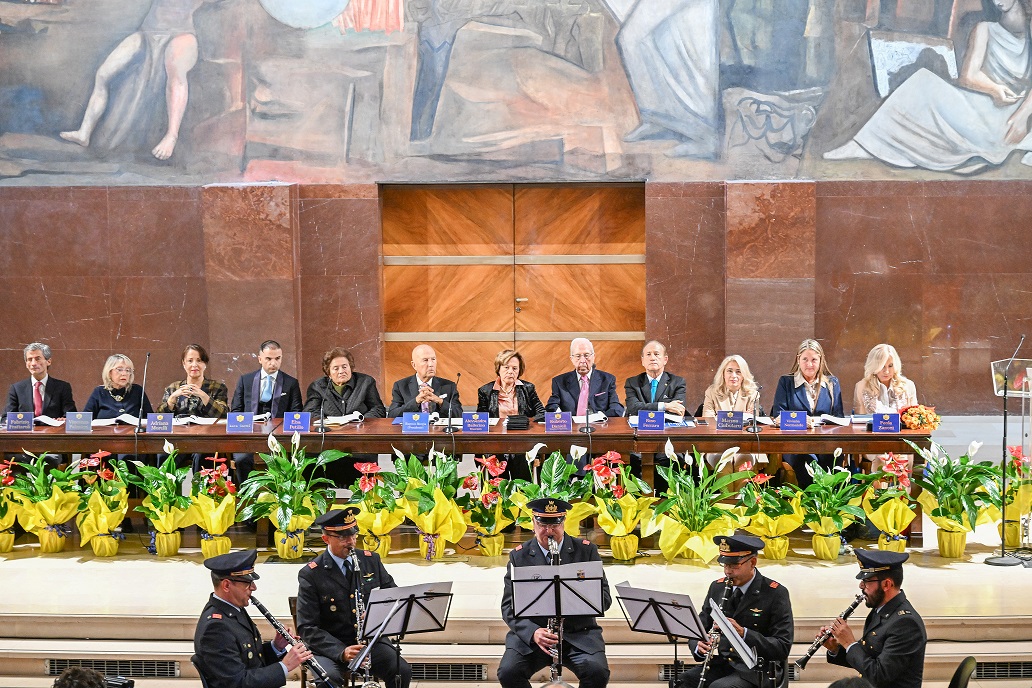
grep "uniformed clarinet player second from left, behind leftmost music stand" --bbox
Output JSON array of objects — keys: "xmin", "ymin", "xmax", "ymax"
[{"xmin": 297, "ymin": 506, "xmax": 412, "ymax": 688}]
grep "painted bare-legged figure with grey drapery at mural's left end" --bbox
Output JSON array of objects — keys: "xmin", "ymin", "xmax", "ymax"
[{"xmin": 61, "ymin": 0, "xmax": 207, "ymax": 160}]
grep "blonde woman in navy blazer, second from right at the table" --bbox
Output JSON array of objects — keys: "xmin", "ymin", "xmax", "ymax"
[{"xmin": 771, "ymin": 339, "xmax": 842, "ymax": 488}]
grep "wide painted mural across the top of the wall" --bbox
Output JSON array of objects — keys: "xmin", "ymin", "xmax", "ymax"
[{"xmin": 0, "ymin": 0, "xmax": 1032, "ymax": 185}]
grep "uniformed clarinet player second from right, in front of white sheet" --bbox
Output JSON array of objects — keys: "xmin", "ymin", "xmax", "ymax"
[{"xmin": 677, "ymin": 534, "xmax": 795, "ymax": 688}]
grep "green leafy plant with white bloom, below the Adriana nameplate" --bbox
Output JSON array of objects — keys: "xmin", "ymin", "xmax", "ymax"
[{"xmin": 115, "ymin": 439, "xmax": 195, "ymax": 557}]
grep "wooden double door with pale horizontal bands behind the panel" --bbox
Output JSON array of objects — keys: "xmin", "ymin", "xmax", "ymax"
[{"xmin": 381, "ymin": 184, "xmax": 645, "ymax": 408}]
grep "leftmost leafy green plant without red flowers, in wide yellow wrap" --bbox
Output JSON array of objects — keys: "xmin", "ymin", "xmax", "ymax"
[{"xmin": 8, "ymin": 452, "xmax": 82, "ymax": 553}]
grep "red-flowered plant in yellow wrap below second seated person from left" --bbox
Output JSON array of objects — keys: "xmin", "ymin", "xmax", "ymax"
[{"xmin": 75, "ymin": 451, "xmax": 129, "ymax": 557}]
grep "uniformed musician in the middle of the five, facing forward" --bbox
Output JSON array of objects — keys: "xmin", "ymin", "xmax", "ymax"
[{"xmin": 498, "ymin": 497, "xmax": 613, "ymax": 688}]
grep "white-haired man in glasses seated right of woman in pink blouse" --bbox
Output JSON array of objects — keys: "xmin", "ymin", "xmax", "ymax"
[{"xmin": 545, "ymin": 337, "xmax": 623, "ymax": 418}]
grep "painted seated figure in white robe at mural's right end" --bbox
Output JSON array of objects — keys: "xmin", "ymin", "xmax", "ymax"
[{"xmin": 824, "ymin": 0, "xmax": 1032, "ymax": 174}]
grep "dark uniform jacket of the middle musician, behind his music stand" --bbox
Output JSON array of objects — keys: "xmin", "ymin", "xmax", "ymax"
[{"xmin": 502, "ymin": 535, "xmax": 613, "ymax": 655}]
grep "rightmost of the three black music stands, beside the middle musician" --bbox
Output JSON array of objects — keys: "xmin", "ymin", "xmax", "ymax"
[{"xmin": 616, "ymin": 583, "xmax": 707, "ymax": 685}]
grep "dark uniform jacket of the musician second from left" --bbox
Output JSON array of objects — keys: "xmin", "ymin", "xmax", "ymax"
[{"xmin": 297, "ymin": 550, "xmax": 397, "ymax": 661}]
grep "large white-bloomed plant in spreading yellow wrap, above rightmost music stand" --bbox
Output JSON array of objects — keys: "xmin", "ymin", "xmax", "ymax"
[{"xmin": 642, "ymin": 440, "xmax": 753, "ymax": 563}]
